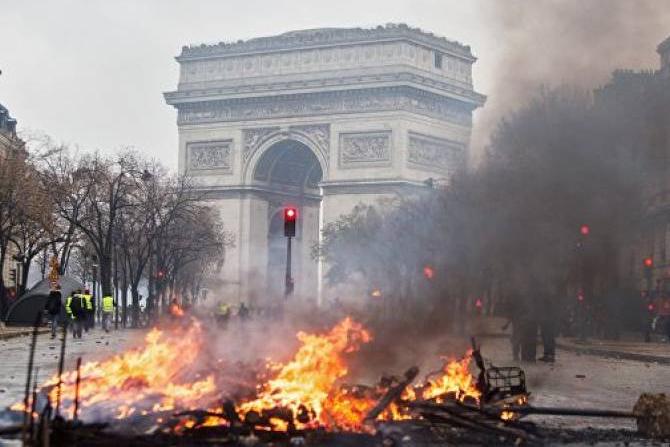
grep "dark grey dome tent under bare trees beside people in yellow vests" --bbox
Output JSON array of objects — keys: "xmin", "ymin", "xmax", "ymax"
[{"xmin": 5, "ymin": 276, "xmax": 84, "ymax": 326}]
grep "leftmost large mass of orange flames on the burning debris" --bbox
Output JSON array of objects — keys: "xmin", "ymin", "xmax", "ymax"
[{"xmin": 15, "ymin": 322, "xmax": 216, "ymax": 419}]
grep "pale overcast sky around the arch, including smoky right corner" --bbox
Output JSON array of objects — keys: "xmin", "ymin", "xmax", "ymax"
[{"xmin": 0, "ymin": 0, "xmax": 670, "ymax": 168}]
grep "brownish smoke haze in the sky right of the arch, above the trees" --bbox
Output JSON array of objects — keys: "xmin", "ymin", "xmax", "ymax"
[{"xmin": 473, "ymin": 0, "xmax": 670, "ymax": 158}]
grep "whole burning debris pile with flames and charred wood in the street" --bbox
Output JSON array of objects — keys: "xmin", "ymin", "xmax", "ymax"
[{"xmin": 2, "ymin": 318, "xmax": 668, "ymax": 446}]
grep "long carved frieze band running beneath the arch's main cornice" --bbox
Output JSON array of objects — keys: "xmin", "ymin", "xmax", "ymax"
[{"xmin": 178, "ymin": 87, "xmax": 472, "ymax": 126}]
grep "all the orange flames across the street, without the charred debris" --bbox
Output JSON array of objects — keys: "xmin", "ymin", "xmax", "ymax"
[{"xmin": 13, "ymin": 317, "xmax": 480, "ymax": 431}]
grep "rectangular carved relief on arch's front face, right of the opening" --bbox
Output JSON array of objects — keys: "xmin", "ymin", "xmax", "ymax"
[{"xmin": 339, "ymin": 132, "xmax": 391, "ymax": 167}]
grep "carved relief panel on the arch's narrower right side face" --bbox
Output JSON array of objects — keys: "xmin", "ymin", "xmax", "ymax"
[{"xmin": 407, "ymin": 132, "xmax": 465, "ymax": 172}]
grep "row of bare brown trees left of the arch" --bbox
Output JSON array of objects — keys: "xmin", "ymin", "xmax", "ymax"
[{"xmin": 0, "ymin": 137, "xmax": 232, "ymax": 325}]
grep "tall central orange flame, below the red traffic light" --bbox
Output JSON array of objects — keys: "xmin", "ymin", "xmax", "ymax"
[{"xmin": 238, "ymin": 317, "xmax": 372, "ymax": 428}]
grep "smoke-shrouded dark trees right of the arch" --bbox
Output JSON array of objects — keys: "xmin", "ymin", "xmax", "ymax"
[{"xmin": 318, "ymin": 84, "xmax": 670, "ymax": 336}]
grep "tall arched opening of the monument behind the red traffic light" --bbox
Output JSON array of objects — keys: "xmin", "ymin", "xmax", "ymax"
[{"xmin": 252, "ymin": 139, "xmax": 323, "ymax": 298}]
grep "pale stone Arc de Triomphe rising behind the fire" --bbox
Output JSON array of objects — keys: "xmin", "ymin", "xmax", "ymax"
[{"xmin": 165, "ymin": 25, "xmax": 484, "ymax": 301}]
